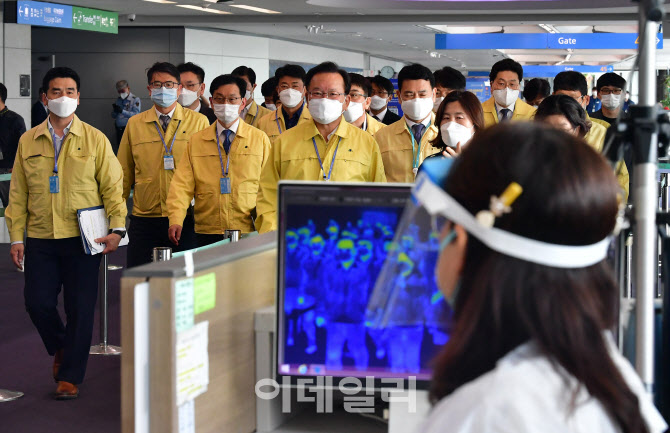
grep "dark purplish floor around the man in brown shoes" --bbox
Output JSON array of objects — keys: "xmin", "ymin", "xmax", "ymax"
[{"xmin": 0, "ymin": 244, "xmax": 125, "ymax": 433}]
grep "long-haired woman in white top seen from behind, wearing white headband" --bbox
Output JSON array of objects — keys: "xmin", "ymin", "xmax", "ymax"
[{"xmin": 410, "ymin": 124, "xmax": 667, "ymax": 433}]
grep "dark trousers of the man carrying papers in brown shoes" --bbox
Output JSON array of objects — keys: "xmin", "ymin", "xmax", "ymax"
[{"xmin": 23, "ymin": 237, "xmax": 102, "ymax": 384}]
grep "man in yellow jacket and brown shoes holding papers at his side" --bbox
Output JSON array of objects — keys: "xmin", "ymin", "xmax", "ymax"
[{"xmin": 5, "ymin": 67, "xmax": 127, "ymax": 400}]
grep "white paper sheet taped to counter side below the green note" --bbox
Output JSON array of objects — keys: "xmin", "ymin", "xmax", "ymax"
[{"xmin": 177, "ymin": 321, "xmax": 209, "ymax": 406}]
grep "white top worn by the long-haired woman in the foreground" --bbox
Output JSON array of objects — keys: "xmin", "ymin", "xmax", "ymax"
[{"xmin": 420, "ymin": 334, "xmax": 668, "ymax": 433}]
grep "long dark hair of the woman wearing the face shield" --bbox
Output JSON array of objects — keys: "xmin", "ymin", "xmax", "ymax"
[{"xmin": 430, "ymin": 123, "xmax": 648, "ymax": 433}]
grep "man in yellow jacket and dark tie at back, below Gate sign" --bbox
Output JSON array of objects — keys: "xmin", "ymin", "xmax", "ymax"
[{"xmin": 482, "ymin": 59, "xmax": 535, "ymax": 128}]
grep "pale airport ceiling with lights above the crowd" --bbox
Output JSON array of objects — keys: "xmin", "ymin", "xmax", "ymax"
[{"xmin": 64, "ymin": 0, "xmax": 670, "ymax": 70}]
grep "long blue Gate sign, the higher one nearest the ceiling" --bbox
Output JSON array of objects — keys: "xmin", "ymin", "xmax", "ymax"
[{"xmin": 435, "ymin": 33, "xmax": 663, "ymax": 50}]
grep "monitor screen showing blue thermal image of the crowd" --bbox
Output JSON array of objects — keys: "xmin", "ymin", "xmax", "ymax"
[{"xmin": 276, "ymin": 182, "xmax": 448, "ymax": 382}]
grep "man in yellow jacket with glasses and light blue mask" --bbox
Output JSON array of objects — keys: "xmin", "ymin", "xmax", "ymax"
[{"xmin": 119, "ymin": 63, "xmax": 209, "ymax": 267}]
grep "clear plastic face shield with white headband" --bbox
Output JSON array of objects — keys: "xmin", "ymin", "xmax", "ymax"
[{"xmin": 367, "ymin": 158, "xmax": 611, "ymax": 329}]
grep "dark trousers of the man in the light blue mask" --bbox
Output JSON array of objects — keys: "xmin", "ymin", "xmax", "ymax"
[{"xmin": 127, "ymin": 214, "xmax": 196, "ymax": 268}]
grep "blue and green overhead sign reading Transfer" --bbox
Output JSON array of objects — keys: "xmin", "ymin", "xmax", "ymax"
[{"xmin": 16, "ymin": 1, "xmax": 119, "ymax": 33}]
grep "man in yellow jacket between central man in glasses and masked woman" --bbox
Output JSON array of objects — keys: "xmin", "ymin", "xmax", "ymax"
[{"xmin": 375, "ymin": 63, "xmax": 439, "ymax": 182}]
